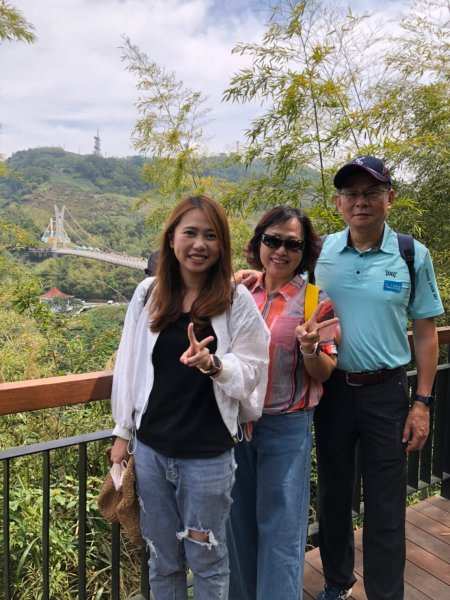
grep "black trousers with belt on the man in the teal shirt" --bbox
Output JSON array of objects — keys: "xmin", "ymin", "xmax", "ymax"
[{"xmin": 315, "ymin": 371, "xmax": 409, "ymax": 600}]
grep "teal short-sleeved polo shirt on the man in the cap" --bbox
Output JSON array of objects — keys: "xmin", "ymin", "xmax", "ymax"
[{"xmin": 316, "ymin": 224, "xmax": 444, "ymax": 371}]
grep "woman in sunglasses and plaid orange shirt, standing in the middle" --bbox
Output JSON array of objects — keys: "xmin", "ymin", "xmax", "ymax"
[{"xmin": 228, "ymin": 206, "xmax": 337, "ymax": 600}]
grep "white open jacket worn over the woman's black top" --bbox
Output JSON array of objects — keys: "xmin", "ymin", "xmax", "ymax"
[{"xmin": 111, "ymin": 277, "xmax": 270, "ymax": 439}]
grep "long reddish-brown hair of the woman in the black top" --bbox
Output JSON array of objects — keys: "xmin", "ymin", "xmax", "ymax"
[{"xmin": 149, "ymin": 195, "xmax": 232, "ymax": 331}]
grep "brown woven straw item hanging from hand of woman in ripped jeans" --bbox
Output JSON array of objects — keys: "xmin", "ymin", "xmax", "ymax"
[{"xmin": 97, "ymin": 456, "xmax": 143, "ymax": 546}]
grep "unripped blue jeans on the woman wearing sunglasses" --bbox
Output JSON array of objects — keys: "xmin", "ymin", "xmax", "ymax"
[{"xmin": 227, "ymin": 410, "xmax": 313, "ymax": 600}]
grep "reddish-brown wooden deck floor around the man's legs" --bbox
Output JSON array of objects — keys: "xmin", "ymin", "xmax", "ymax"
[{"xmin": 304, "ymin": 496, "xmax": 450, "ymax": 600}]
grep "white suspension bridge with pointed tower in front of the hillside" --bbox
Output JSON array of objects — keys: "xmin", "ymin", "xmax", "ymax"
[{"xmin": 41, "ymin": 205, "xmax": 147, "ymax": 271}]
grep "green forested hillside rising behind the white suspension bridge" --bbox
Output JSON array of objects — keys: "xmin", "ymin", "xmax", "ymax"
[{"xmin": 0, "ymin": 148, "xmax": 282, "ymax": 256}]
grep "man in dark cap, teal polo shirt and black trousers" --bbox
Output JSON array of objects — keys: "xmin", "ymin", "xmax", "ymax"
[{"xmin": 315, "ymin": 156, "xmax": 443, "ymax": 600}]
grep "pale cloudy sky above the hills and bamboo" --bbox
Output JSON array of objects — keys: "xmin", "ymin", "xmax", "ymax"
[{"xmin": 0, "ymin": 0, "xmax": 406, "ymax": 156}]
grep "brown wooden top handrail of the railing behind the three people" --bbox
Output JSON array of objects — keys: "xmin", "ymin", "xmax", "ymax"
[{"xmin": 0, "ymin": 327, "xmax": 450, "ymax": 416}]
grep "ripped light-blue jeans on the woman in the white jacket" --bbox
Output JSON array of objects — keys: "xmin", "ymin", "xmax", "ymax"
[{"xmin": 135, "ymin": 440, "xmax": 235, "ymax": 600}]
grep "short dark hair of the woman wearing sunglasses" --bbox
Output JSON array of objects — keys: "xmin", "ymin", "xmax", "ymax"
[{"xmin": 246, "ymin": 206, "xmax": 322, "ymax": 282}]
